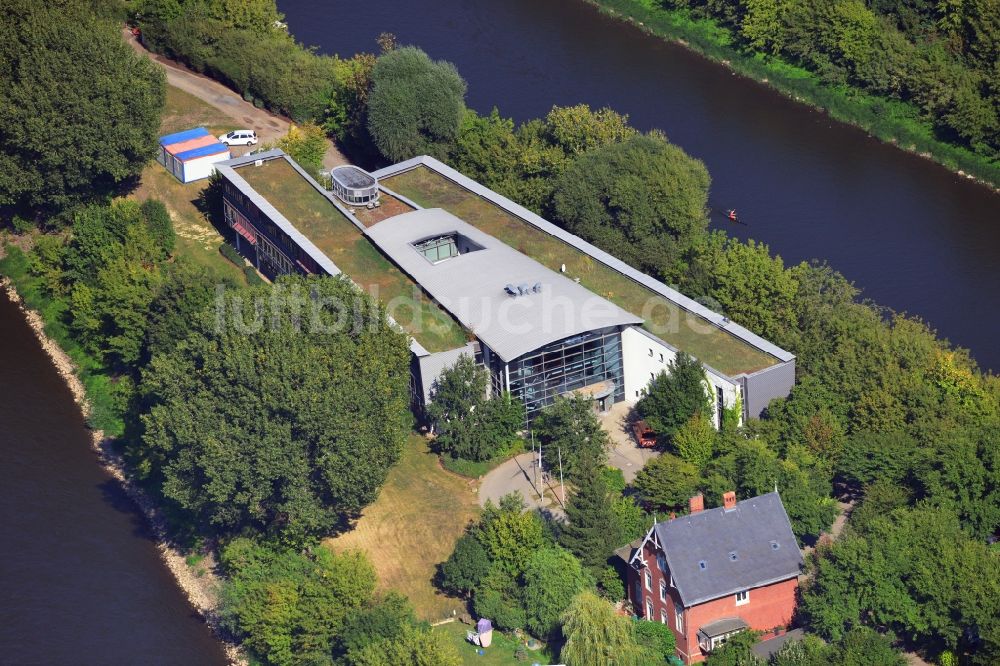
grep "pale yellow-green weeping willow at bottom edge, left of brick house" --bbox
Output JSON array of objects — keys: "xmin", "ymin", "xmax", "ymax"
[{"xmin": 559, "ymin": 591, "xmax": 649, "ymax": 666}]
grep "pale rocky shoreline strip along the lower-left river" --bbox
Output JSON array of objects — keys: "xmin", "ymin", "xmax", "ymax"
[{"xmin": 0, "ymin": 277, "xmax": 249, "ymax": 666}]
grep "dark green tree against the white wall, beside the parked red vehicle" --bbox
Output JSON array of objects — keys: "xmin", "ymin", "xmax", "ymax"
[{"xmin": 635, "ymin": 352, "xmax": 712, "ymax": 441}]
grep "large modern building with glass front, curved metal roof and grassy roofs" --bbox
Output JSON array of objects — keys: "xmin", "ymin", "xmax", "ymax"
[{"xmin": 217, "ymin": 150, "xmax": 795, "ymax": 423}]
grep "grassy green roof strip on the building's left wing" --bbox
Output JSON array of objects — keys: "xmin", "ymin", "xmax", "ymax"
[{"xmin": 238, "ymin": 159, "xmax": 468, "ymax": 352}]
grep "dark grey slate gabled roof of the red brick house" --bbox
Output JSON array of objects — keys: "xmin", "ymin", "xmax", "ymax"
[{"xmin": 653, "ymin": 492, "xmax": 802, "ymax": 607}]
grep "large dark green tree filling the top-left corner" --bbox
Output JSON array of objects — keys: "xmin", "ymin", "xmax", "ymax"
[{"xmin": 0, "ymin": 0, "xmax": 165, "ymax": 218}]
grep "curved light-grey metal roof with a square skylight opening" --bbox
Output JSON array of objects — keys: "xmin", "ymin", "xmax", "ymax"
[{"xmin": 365, "ymin": 208, "xmax": 642, "ymax": 362}]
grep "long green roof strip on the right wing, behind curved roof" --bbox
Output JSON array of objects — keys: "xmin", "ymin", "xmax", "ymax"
[{"xmin": 381, "ymin": 166, "xmax": 778, "ymax": 375}]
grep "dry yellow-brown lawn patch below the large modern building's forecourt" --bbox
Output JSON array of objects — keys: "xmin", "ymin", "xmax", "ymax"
[{"xmin": 325, "ymin": 434, "xmax": 479, "ymax": 620}]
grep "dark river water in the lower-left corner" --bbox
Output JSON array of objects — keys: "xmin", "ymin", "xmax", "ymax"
[{"xmin": 0, "ymin": 291, "xmax": 226, "ymax": 666}]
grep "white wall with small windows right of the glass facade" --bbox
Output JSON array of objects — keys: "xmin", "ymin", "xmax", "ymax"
[{"xmin": 622, "ymin": 326, "xmax": 741, "ymax": 428}]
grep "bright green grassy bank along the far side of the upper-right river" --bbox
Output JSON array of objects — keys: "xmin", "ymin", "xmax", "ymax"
[{"xmin": 584, "ymin": 0, "xmax": 1000, "ymax": 193}]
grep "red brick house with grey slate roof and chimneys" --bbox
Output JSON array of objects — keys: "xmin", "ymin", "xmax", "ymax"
[{"xmin": 617, "ymin": 492, "xmax": 802, "ymax": 664}]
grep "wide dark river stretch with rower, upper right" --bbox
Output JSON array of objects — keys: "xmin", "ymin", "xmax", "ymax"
[{"xmin": 278, "ymin": 0, "xmax": 1000, "ymax": 371}]
